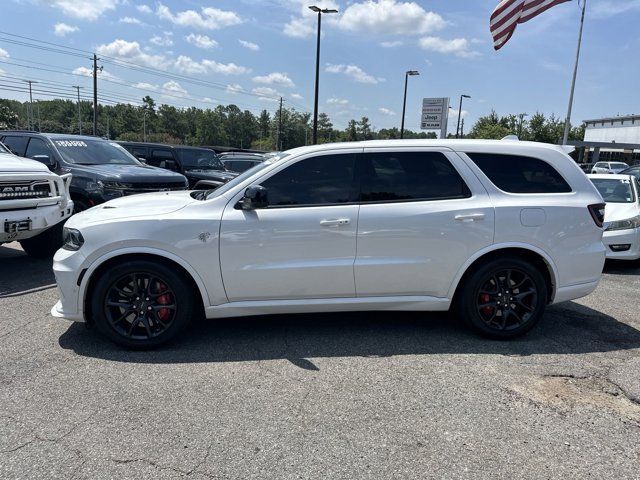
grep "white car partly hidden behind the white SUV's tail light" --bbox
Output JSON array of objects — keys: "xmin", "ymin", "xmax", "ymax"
[{"xmin": 588, "ymin": 174, "xmax": 640, "ymax": 260}]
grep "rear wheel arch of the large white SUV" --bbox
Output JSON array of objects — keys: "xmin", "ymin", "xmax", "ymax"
[{"xmin": 449, "ymin": 244, "xmax": 558, "ymax": 304}]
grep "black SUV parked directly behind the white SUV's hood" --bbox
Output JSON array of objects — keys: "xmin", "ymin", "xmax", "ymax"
[{"xmin": 118, "ymin": 142, "xmax": 238, "ymax": 189}]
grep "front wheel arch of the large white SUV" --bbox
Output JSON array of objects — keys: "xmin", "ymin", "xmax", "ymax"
[{"xmin": 79, "ymin": 249, "xmax": 209, "ymax": 323}]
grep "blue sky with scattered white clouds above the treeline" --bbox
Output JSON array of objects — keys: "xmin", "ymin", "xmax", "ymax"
[{"xmin": 0, "ymin": 0, "xmax": 640, "ymax": 132}]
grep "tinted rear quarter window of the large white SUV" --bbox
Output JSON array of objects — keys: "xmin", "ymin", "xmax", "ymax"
[{"xmin": 467, "ymin": 153, "xmax": 571, "ymax": 193}]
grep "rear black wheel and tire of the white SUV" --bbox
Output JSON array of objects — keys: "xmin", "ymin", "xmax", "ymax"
[{"xmin": 455, "ymin": 257, "xmax": 548, "ymax": 340}]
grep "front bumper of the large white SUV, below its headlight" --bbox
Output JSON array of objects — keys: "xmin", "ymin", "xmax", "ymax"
[{"xmin": 51, "ymin": 249, "xmax": 85, "ymax": 322}]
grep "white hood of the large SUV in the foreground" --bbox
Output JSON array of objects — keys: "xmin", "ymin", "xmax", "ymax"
[{"xmin": 69, "ymin": 191, "xmax": 198, "ymax": 228}]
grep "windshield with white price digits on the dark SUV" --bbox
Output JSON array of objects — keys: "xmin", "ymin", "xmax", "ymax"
[{"xmin": 53, "ymin": 138, "xmax": 142, "ymax": 165}]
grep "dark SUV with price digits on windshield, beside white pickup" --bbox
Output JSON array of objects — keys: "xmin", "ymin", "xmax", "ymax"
[{"xmin": 0, "ymin": 131, "xmax": 187, "ymax": 211}]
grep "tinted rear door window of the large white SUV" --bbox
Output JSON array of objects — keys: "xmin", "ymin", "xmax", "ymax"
[{"xmin": 358, "ymin": 152, "xmax": 471, "ymax": 203}]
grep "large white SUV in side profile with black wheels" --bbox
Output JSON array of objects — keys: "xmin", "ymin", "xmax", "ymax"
[{"xmin": 52, "ymin": 140, "xmax": 605, "ymax": 348}]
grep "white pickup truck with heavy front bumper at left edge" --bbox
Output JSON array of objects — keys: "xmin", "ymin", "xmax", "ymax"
[{"xmin": 0, "ymin": 144, "xmax": 73, "ymax": 258}]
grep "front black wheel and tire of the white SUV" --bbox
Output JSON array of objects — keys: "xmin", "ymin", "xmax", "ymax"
[{"xmin": 90, "ymin": 260, "xmax": 198, "ymax": 350}]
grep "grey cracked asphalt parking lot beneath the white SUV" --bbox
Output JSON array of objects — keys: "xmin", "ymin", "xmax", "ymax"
[{"xmin": 0, "ymin": 244, "xmax": 640, "ymax": 479}]
